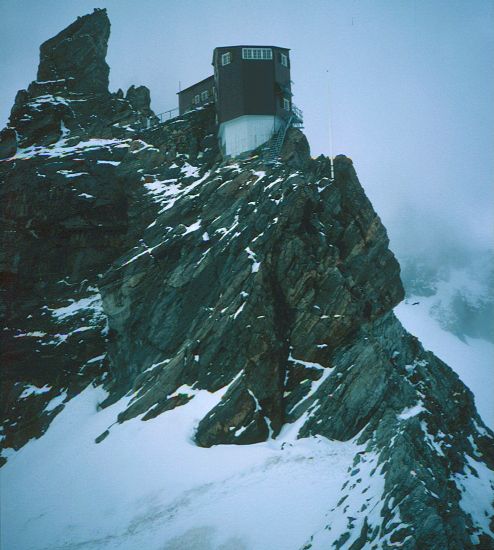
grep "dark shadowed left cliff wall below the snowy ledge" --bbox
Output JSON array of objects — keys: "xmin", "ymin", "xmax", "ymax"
[{"xmin": 0, "ymin": 104, "xmax": 217, "ymax": 458}]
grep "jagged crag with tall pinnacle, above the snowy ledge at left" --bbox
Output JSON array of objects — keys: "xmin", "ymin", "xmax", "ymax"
[{"xmin": 0, "ymin": 9, "xmax": 158, "ymax": 155}]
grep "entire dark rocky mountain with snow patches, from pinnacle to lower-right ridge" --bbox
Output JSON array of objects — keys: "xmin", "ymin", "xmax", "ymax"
[{"xmin": 0, "ymin": 10, "xmax": 494, "ymax": 549}]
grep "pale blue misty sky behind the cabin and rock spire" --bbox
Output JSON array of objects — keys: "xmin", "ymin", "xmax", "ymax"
[{"xmin": 0, "ymin": 0, "xmax": 494, "ymax": 264}]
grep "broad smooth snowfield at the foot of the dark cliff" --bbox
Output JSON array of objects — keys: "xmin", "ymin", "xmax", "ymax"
[{"xmin": 0, "ymin": 386, "xmax": 370, "ymax": 550}]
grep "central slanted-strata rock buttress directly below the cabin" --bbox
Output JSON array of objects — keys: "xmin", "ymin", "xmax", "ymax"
[{"xmin": 100, "ymin": 151, "xmax": 403, "ymax": 440}]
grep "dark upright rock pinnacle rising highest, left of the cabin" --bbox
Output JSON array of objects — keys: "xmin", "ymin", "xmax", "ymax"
[{"xmin": 38, "ymin": 9, "xmax": 110, "ymax": 93}]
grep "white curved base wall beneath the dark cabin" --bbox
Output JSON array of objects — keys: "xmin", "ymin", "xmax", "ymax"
[{"xmin": 218, "ymin": 115, "xmax": 282, "ymax": 157}]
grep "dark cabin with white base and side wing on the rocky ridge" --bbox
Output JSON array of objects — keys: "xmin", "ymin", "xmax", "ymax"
[{"xmin": 178, "ymin": 45, "xmax": 302, "ymax": 156}]
